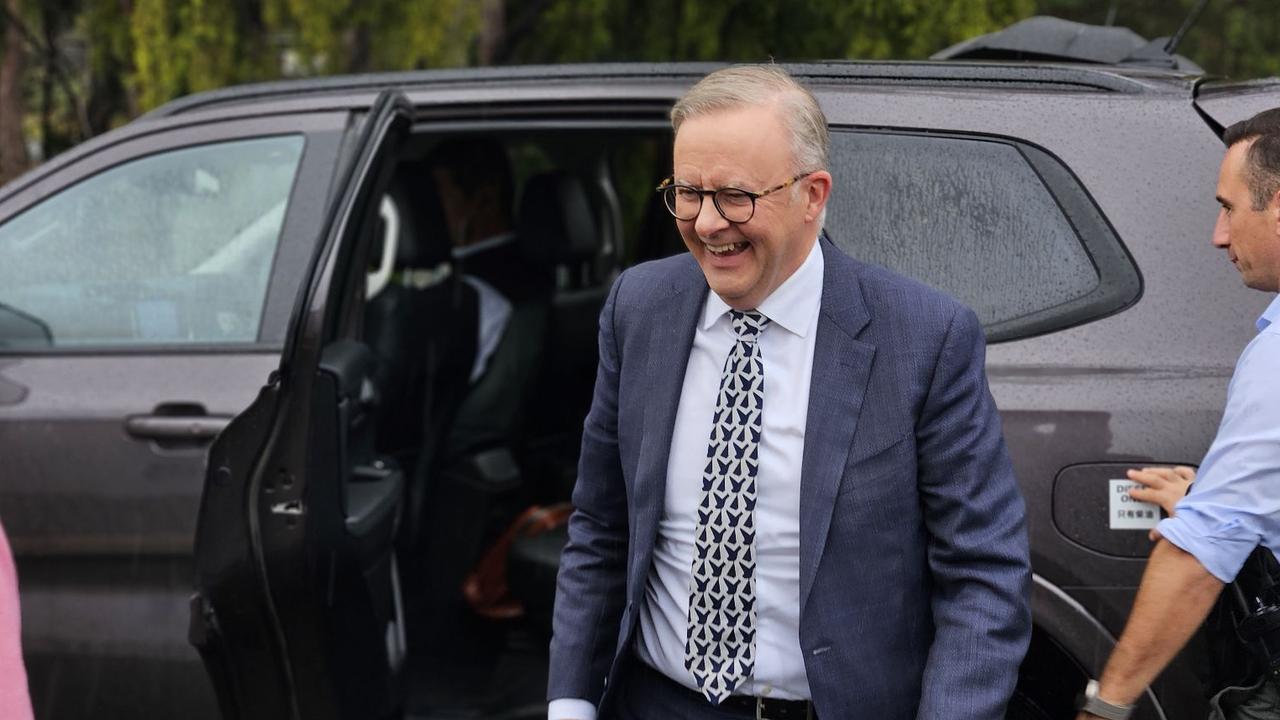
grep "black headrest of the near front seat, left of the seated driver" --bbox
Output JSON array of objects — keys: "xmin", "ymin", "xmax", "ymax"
[{"xmin": 388, "ymin": 161, "xmax": 452, "ymax": 268}]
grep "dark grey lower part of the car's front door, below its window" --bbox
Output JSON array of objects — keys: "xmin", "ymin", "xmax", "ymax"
[{"xmin": 0, "ymin": 354, "xmax": 278, "ymax": 717}]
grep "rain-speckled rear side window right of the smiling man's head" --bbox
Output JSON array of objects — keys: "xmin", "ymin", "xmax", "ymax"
[{"xmin": 827, "ymin": 131, "xmax": 1140, "ymax": 341}]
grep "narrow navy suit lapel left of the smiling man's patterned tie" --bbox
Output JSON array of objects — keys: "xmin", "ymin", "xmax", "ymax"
[{"xmin": 632, "ymin": 258, "xmax": 707, "ymax": 589}]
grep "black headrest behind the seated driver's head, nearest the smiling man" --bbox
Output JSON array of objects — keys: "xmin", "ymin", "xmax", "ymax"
[{"xmin": 518, "ymin": 170, "xmax": 600, "ymax": 265}]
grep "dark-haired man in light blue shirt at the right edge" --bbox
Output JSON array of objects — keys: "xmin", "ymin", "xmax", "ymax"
[{"xmin": 1078, "ymin": 109, "xmax": 1280, "ymax": 720}]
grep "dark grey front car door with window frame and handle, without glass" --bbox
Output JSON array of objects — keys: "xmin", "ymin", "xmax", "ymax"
[{"xmin": 0, "ymin": 110, "xmax": 344, "ymax": 719}]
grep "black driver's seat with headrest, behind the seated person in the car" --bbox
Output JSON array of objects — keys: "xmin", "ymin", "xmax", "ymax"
[{"xmin": 419, "ymin": 172, "xmax": 603, "ymax": 638}]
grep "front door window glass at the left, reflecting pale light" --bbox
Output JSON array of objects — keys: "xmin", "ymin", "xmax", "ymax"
[{"xmin": 0, "ymin": 136, "xmax": 303, "ymax": 348}]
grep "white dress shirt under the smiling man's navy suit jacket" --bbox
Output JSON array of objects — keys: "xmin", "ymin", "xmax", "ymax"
[{"xmin": 548, "ymin": 241, "xmax": 824, "ymax": 720}]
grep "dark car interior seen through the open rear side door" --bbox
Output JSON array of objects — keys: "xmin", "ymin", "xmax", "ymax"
[{"xmin": 345, "ymin": 131, "xmax": 684, "ymax": 719}]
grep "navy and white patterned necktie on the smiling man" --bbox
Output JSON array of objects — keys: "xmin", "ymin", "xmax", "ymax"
[{"xmin": 685, "ymin": 310, "xmax": 769, "ymax": 705}]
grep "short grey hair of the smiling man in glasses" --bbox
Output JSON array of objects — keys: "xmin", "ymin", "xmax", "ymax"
[{"xmin": 671, "ymin": 64, "xmax": 831, "ymax": 174}]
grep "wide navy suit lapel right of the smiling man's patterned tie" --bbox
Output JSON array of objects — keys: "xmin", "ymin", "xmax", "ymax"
[{"xmin": 800, "ymin": 240, "xmax": 876, "ymax": 611}]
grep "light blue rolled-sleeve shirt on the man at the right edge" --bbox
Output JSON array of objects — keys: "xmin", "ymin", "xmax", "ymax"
[{"xmin": 1158, "ymin": 297, "xmax": 1280, "ymax": 583}]
